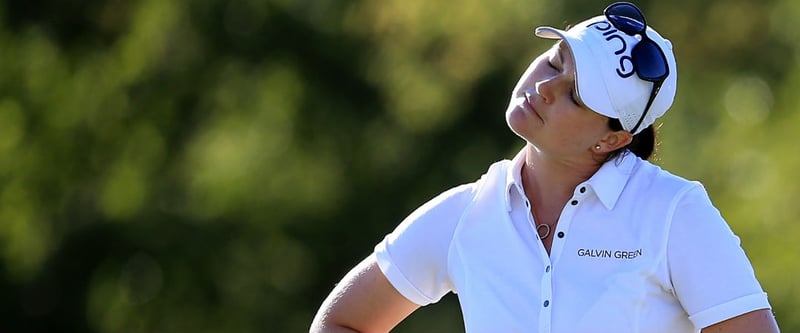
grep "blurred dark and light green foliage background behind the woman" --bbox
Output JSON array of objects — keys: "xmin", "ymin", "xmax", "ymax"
[{"xmin": 0, "ymin": 0, "xmax": 800, "ymax": 333}]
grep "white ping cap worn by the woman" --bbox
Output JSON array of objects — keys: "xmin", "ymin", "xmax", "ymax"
[{"xmin": 536, "ymin": 16, "xmax": 678, "ymax": 134}]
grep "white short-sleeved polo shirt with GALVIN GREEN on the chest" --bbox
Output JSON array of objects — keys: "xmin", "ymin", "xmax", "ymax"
[{"xmin": 375, "ymin": 150, "xmax": 770, "ymax": 333}]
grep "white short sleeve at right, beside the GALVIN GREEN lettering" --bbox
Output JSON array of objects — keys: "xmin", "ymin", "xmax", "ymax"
[{"xmin": 667, "ymin": 184, "xmax": 770, "ymax": 329}]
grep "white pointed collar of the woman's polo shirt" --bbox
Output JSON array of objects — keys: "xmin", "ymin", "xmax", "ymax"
[{"xmin": 505, "ymin": 148, "xmax": 642, "ymax": 211}]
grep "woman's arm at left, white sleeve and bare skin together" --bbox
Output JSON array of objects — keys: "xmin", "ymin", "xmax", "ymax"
[{"xmin": 311, "ymin": 184, "xmax": 474, "ymax": 332}]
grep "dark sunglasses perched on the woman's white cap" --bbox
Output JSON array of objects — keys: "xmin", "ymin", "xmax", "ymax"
[{"xmin": 603, "ymin": 2, "xmax": 669, "ymax": 133}]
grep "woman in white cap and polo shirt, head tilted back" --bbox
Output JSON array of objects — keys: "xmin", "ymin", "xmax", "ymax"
[{"xmin": 311, "ymin": 3, "xmax": 778, "ymax": 333}]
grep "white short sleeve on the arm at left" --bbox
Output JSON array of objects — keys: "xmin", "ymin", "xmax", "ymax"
[{"xmin": 375, "ymin": 183, "xmax": 474, "ymax": 305}]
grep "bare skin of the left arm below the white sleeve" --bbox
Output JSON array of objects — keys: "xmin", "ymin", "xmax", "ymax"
[{"xmin": 311, "ymin": 254, "xmax": 419, "ymax": 333}]
